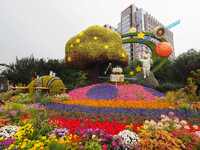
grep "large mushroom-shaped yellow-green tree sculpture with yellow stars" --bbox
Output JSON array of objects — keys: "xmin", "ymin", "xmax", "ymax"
[{"xmin": 65, "ymin": 26, "xmax": 128, "ymax": 81}]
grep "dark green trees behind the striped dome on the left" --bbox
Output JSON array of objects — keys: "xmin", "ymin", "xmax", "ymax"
[{"xmin": 0, "ymin": 56, "xmax": 89, "ymax": 89}]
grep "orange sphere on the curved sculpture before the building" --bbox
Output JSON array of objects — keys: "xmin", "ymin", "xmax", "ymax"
[{"xmin": 155, "ymin": 42, "xmax": 173, "ymax": 57}]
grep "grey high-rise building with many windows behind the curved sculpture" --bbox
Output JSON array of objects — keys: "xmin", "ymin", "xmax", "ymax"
[{"xmin": 117, "ymin": 4, "xmax": 174, "ymax": 61}]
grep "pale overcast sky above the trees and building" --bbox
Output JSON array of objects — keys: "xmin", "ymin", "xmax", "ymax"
[{"xmin": 0, "ymin": 0, "xmax": 200, "ymax": 63}]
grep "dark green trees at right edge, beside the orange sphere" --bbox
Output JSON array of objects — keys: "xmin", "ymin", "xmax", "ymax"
[{"xmin": 155, "ymin": 49, "xmax": 200, "ymax": 85}]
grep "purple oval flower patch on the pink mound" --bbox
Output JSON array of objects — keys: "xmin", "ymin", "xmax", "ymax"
[{"xmin": 86, "ymin": 84, "xmax": 118, "ymax": 99}]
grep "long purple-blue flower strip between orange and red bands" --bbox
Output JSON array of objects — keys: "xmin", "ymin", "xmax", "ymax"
[{"xmin": 46, "ymin": 103, "xmax": 200, "ymax": 118}]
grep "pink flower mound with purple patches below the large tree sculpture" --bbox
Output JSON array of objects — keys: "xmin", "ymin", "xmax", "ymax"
[{"xmin": 69, "ymin": 83, "xmax": 164, "ymax": 100}]
